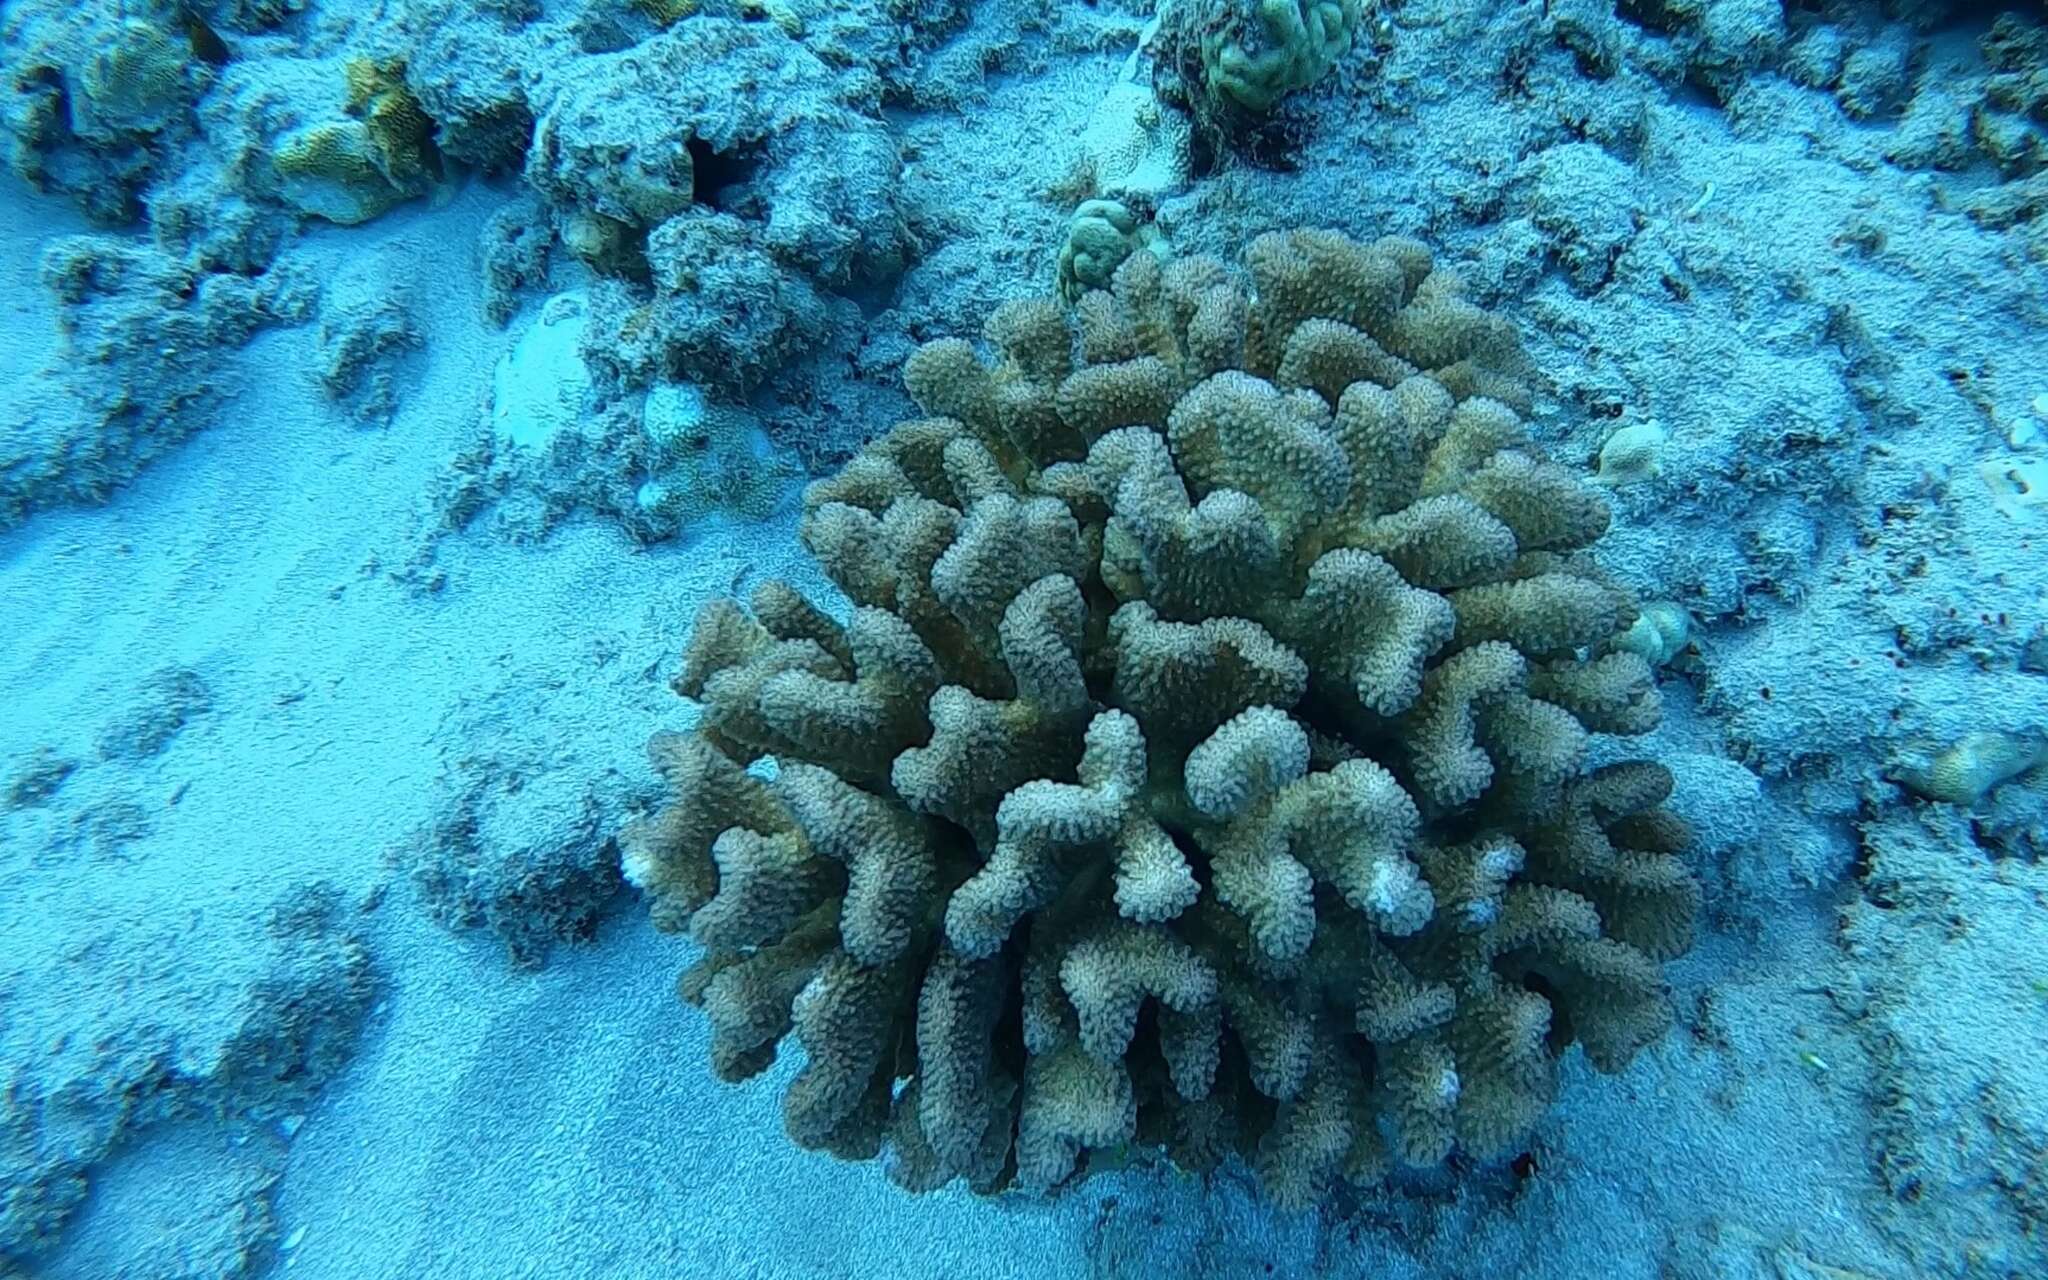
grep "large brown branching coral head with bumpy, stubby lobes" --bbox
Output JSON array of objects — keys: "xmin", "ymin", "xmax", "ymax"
[{"xmin": 625, "ymin": 231, "xmax": 1698, "ymax": 1206}]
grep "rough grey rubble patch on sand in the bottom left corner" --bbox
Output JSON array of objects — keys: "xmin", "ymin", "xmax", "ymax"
[{"xmin": 0, "ymin": 883, "xmax": 381, "ymax": 1276}]
